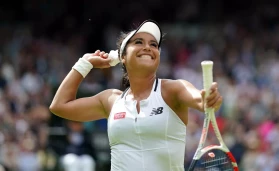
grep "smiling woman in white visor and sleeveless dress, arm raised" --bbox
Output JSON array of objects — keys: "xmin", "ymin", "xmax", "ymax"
[{"xmin": 50, "ymin": 20, "xmax": 222, "ymax": 171}]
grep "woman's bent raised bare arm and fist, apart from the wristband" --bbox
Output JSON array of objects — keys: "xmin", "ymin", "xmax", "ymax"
[{"xmin": 49, "ymin": 51, "xmax": 121, "ymax": 121}]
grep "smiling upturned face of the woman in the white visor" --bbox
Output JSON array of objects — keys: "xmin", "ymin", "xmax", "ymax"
[{"xmin": 122, "ymin": 33, "xmax": 160, "ymax": 76}]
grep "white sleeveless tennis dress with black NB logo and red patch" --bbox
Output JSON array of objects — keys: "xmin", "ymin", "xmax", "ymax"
[{"xmin": 108, "ymin": 79, "xmax": 186, "ymax": 171}]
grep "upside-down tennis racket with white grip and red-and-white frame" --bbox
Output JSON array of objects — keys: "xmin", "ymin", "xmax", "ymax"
[{"xmin": 188, "ymin": 61, "xmax": 238, "ymax": 171}]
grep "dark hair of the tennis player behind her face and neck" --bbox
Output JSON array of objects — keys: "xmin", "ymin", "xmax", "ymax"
[{"xmin": 116, "ymin": 32, "xmax": 130, "ymax": 90}]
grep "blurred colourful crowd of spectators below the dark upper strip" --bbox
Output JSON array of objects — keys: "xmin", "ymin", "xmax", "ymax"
[{"xmin": 0, "ymin": 1, "xmax": 279, "ymax": 171}]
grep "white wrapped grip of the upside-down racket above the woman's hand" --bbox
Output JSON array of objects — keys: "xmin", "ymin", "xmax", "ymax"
[{"xmin": 201, "ymin": 61, "xmax": 213, "ymax": 97}]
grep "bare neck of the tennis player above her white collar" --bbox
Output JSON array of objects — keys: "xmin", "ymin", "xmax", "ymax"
[{"xmin": 129, "ymin": 75, "xmax": 156, "ymax": 100}]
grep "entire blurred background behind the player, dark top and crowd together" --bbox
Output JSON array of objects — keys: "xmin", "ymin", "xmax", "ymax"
[{"xmin": 0, "ymin": 0, "xmax": 279, "ymax": 171}]
